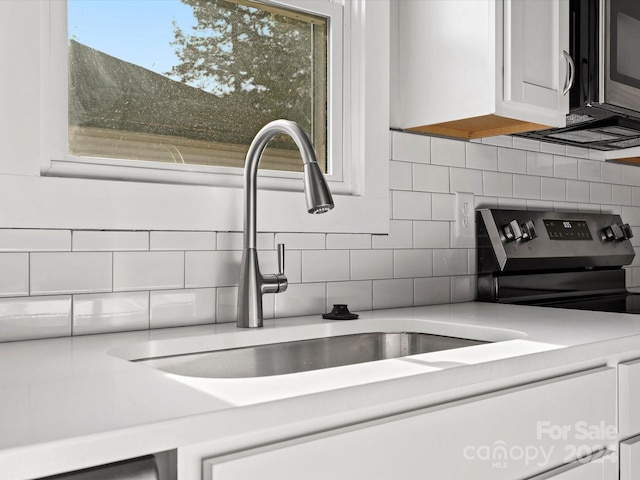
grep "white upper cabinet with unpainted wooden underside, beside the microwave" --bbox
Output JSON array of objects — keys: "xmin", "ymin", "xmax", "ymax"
[{"xmin": 391, "ymin": 0, "xmax": 571, "ymax": 138}]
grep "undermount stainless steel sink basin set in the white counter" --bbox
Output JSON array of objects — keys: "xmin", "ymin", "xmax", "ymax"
[{"xmin": 133, "ymin": 332, "xmax": 488, "ymax": 378}]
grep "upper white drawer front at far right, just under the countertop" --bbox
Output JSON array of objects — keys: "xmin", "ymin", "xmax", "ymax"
[{"xmin": 618, "ymin": 359, "xmax": 640, "ymax": 437}]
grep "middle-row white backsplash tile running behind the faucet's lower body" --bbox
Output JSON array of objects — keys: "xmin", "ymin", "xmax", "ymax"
[{"xmin": 184, "ymin": 251, "xmax": 242, "ymax": 288}]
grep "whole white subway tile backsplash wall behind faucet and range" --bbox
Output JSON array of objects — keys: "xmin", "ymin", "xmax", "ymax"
[{"xmin": 0, "ymin": 132, "xmax": 640, "ymax": 341}]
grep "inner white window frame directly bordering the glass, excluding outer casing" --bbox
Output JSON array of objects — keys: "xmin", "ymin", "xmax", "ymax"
[{"xmin": 50, "ymin": 0, "xmax": 352, "ymax": 193}]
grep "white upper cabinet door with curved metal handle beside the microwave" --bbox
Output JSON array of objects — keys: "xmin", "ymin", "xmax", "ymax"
[{"xmin": 503, "ymin": 0, "xmax": 569, "ymax": 113}]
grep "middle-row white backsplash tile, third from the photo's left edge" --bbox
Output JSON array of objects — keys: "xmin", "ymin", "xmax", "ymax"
[{"xmin": 113, "ymin": 252, "xmax": 185, "ymax": 291}]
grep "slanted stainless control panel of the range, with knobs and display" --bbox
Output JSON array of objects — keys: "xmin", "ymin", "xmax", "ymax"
[{"xmin": 476, "ymin": 209, "xmax": 635, "ymax": 270}]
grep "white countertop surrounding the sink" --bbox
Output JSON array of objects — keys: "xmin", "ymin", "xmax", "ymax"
[{"xmin": 0, "ymin": 302, "xmax": 640, "ymax": 480}]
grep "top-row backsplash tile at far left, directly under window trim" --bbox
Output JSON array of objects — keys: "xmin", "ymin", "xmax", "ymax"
[{"xmin": 0, "ymin": 228, "xmax": 71, "ymax": 252}]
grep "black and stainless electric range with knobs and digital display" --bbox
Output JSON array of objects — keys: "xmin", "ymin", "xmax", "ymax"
[{"xmin": 476, "ymin": 209, "xmax": 640, "ymax": 313}]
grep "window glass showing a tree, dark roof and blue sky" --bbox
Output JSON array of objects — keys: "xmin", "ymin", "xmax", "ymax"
[{"xmin": 68, "ymin": 0, "xmax": 328, "ymax": 172}]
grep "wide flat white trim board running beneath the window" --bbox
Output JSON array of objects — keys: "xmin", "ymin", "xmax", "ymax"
[{"xmin": 0, "ymin": 175, "xmax": 389, "ymax": 233}]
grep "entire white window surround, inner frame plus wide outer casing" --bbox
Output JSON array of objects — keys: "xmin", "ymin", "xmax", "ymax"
[{"xmin": 0, "ymin": 0, "xmax": 389, "ymax": 233}]
